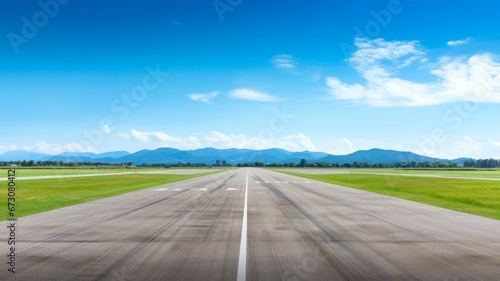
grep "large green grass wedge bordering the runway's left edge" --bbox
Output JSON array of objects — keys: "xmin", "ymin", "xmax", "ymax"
[{"xmin": 0, "ymin": 172, "xmax": 217, "ymax": 221}]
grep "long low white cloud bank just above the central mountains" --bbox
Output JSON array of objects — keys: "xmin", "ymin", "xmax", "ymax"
[{"xmin": 131, "ymin": 130, "xmax": 315, "ymax": 151}]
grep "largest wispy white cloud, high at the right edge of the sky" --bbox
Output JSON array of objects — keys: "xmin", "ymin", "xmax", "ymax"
[{"xmin": 326, "ymin": 38, "xmax": 500, "ymax": 107}]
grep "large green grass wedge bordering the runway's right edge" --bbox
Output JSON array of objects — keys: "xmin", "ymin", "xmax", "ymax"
[{"xmin": 280, "ymin": 171, "xmax": 500, "ymax": 220}]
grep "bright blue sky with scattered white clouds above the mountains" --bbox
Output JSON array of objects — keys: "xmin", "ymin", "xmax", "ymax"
[{"xmin": 0, "ymin": 0, "xmax": 500, "ymax": 158}]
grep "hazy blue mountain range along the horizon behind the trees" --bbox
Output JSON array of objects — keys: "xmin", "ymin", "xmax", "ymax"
[{"xmin": 0, "ymin": 148, "xmax": 470, "ymax": 165}]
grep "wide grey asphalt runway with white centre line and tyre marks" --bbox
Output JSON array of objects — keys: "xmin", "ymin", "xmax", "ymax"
[{"xmin": 0, "ymin": 169, "xmax": 500, "ymax": 281}]
